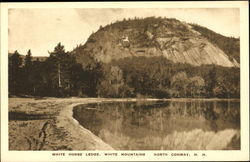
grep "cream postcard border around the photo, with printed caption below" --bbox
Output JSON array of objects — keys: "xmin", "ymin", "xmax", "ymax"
[{"xmin": 1, "ymin": 1, "xmax": 249, "ymax": 161}]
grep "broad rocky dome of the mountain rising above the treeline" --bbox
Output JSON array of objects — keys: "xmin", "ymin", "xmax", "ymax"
[{"xmin": 76, "ymin": 18, "xmax": 240, "ymax": 67}]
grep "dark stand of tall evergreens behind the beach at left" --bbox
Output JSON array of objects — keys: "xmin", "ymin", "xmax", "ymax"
[{"xmin": 9, "ymin": 43, "xmax": 102, "ymax": 97}]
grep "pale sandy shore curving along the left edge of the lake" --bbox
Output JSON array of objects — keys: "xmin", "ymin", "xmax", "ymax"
[{"xmin": 9, "ymin": 98, "xmax": 157, "ymax": 150}]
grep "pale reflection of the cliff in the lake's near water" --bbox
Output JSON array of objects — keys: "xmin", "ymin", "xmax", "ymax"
[{"xmin": 99, "ymin": 129, "xmax": 240, "ymax": 150}]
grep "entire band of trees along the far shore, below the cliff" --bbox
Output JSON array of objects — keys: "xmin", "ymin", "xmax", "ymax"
[{"xmin": 9, "ymin": 43, "xmax": 240, "ymax": 98}]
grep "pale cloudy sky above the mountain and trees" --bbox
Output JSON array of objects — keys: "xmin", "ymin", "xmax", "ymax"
[{"xmin": 8, "ymin": 8, "xmax": 240, "ymax": 56}]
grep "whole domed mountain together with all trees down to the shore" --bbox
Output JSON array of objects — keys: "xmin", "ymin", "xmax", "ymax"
[{"xmin": 9, "ymin": 17, "xmax": 240, "ymax": 98}]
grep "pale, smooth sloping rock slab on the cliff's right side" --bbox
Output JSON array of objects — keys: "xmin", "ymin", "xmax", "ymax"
[{"xmin": 162, "ymin": 38, "xmax": 239, "ymax": 67}]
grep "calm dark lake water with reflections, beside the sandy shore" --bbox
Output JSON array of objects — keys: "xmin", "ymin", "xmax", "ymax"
[{"xmin": 73, "ymin": 100, "xmax": 240, "ymax": 150}]
